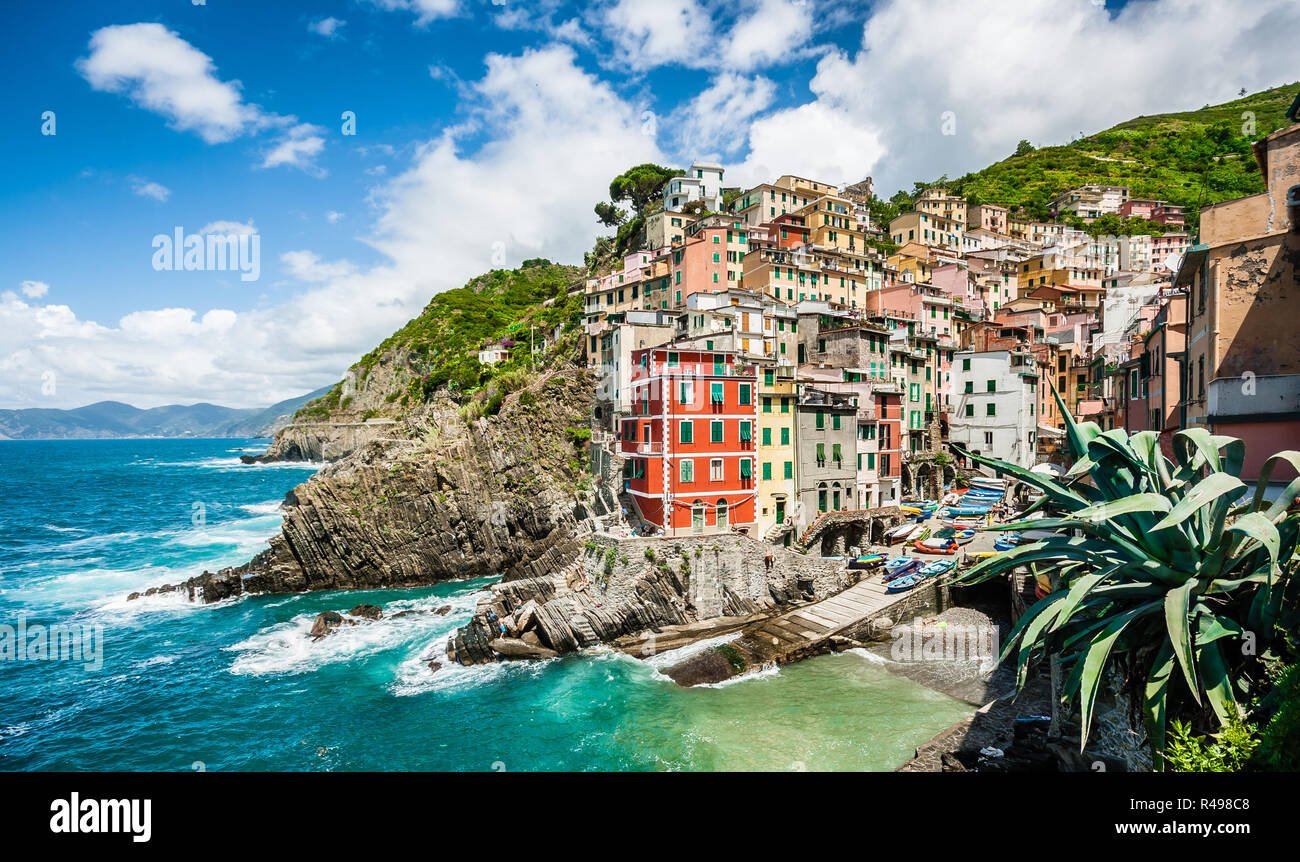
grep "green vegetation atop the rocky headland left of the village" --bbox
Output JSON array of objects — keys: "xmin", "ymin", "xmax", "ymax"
[{"xmin": 295, "ymin": 259, "xmax": 582, "ymax": 419}]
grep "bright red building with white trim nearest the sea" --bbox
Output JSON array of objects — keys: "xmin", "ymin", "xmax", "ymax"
[{"xmin": 620, "ymin": 346, "xmax": 758, "ymax": 536}]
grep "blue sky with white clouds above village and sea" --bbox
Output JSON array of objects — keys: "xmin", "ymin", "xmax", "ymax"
[{"xmin": 0, "ymin": 0, "xmax": 1300, "ymax": 408}]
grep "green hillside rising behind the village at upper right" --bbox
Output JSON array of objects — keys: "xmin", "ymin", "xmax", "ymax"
[{"xmin": 874, "ymin": 83, "xmax": 1300, "ymax": 231}]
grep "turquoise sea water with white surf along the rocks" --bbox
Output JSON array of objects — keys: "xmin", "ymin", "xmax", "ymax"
[{"xmin": 0, "ymin": 439, "xmax": 970, "ymax": 771}]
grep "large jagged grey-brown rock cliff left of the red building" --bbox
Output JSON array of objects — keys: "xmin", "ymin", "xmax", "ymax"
[{"xmin": 156, "ymin": 367, "xmax": 594, "ymax": 602}]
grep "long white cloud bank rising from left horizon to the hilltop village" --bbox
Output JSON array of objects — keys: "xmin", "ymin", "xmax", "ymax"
[{"xmin": 0, "ymin": 46, "xmax": 663, "ymax": 407}]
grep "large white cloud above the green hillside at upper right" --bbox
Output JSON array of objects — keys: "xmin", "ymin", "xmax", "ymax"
[{"xmin": 810, "ymin": 0, "xmax": 1300, "ymax": 194}]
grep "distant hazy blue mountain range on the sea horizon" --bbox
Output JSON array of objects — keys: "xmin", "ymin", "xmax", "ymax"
[{"xmin": 0, "ymin": 386, "xmax": 330, "ymax": 439}]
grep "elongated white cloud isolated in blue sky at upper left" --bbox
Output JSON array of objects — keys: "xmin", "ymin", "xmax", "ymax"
[{"xmin": 77, "ymin": 23, "xmax": 325, "ymax": 174}]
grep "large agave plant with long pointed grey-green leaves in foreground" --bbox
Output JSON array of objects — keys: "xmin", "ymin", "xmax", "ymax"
[{"xmin": 962, "ymin": 395, "xmax": 1300, "ymax": 764}]
